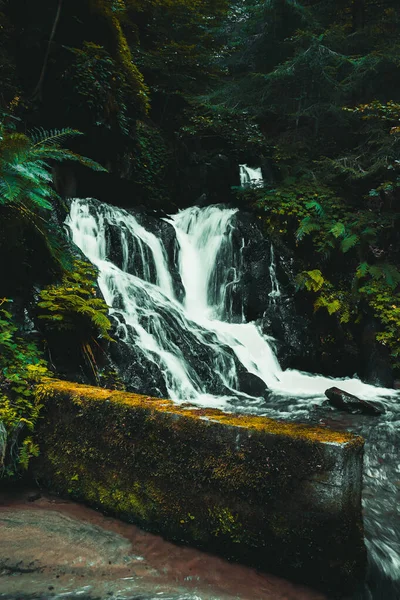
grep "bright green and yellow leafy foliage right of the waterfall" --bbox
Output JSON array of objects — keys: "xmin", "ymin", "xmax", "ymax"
[{"xmin": 253, "ymin": 169, "xmax": 400, "ymax": 368}]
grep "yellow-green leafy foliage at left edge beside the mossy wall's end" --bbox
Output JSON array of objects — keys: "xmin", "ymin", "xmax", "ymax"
[{"xmin": 0, "ymin": 298, "xmax": 50, "ymax": 477}]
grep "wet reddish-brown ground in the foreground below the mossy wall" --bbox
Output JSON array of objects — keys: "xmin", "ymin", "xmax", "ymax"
[{"xmin": 0, "ymin": 492, "xmax": 325, "ymax": 600}]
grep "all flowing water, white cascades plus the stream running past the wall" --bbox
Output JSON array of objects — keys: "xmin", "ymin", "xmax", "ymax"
[{"xmin": 67, "ymin": 200, "xmax": 400, "ymax": 600}]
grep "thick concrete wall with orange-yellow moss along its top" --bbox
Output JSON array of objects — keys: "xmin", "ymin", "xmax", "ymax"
[{"xmin": 35, "ymin": 381, "xmax": 365, "ymax": 597}]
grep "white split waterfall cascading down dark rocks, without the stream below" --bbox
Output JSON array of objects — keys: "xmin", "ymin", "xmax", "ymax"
[{"xmin": 67, "ymin": 199, "xmax": 394, "ymax": 408}]
